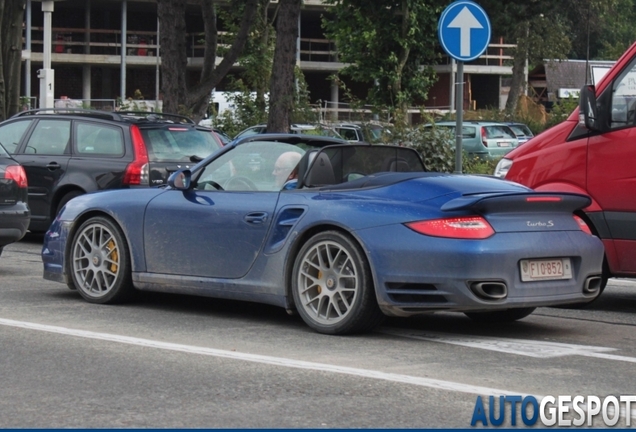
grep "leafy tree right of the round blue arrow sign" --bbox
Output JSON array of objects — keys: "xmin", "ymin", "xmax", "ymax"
[{"xmin": 480, "ymin": 0, "xmax": 624, "ymax": 113}]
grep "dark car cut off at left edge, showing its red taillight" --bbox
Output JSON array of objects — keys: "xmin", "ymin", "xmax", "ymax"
[{"xmin": 0, "ymin": 140, "xmax": 31, "ymax": 255}]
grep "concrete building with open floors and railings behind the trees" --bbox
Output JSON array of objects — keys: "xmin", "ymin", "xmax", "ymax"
[{"xmin": 22, "ymin": 0, "xmax": 511, "ymax": 120}]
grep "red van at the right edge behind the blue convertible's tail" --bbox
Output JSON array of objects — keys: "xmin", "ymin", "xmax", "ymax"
[{"xmin": 495, "ymin": 43, "xmax": 636, "ymax": 287}]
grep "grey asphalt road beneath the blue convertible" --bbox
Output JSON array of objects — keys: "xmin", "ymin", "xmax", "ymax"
[{"xmin": 0, "ymin": 236, "xmax": 636, "ymax": 428}]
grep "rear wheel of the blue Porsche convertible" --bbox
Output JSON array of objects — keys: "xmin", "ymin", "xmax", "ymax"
[{"xmin": 292, "ymin": 231, "xmax": 384, "ymax": 335}]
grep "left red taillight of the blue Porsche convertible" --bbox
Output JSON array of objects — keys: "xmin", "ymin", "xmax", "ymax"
[{"xmin": 406, "ymin": 216, "xmax": 495, "ymax": 239}]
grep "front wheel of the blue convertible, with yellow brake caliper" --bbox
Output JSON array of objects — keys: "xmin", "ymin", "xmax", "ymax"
[{"xmin": 66, "ymin": 216, "xmax": 134, "ymax": 304}]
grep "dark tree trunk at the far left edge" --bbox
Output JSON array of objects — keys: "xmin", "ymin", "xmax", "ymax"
[{"xmin": 0, "ymin": 0, "xmax": 26, "ymax": 120}]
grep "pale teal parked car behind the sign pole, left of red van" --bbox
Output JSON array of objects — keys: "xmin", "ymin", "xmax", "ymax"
[{"xmin": 424, "ymin": 121, "xmax": 519, "ymax": 159}]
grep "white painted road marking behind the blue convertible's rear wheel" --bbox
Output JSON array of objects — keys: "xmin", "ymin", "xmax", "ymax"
[{"xmin": 381, "ymin": 330, "xmax": 636, "ymax": 363}]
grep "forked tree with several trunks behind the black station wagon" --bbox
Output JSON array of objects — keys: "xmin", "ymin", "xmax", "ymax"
[{"xmin": 157, "ymin": 0, "xmax": 259, "ymax": 121}]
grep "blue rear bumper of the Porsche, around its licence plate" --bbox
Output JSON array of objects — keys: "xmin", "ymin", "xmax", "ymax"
[{"xmin": 359, "ymin": 227, "xmax": 603, "ymax": 316}]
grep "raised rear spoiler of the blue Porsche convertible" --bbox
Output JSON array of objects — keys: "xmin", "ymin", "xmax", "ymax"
[{"xmin": 441, "ymin": 192, "xmax": 592, "ymax": 213}]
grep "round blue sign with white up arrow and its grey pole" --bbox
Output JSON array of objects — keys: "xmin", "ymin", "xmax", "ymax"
[{"xmin": 437, "ymin": 0, "xmax": 491, "ymax": 174}]
